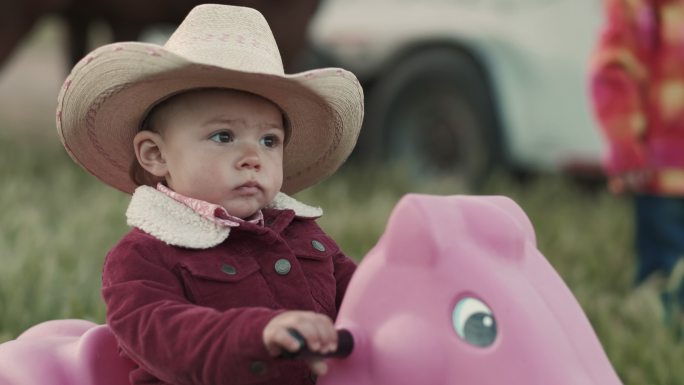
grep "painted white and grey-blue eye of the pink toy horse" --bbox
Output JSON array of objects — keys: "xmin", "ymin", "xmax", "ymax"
[{"xmin": 452, "ymin": 297, "xmax": 496, "ymax": 347}]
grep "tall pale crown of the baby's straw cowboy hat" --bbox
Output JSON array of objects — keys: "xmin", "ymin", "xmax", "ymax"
[{"xmin": 164, "ymin": 4, "xmax": 284, "ymax": 75}]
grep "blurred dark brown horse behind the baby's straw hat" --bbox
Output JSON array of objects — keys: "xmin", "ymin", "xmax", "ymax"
[{"xmin": 0, "ymin": 0, "xmax": 319, "ymax": 70}]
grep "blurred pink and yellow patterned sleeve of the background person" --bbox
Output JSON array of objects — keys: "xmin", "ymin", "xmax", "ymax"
[{"xmin": 590, "ymin": 0, "xmax": 658, "ymax": 175}]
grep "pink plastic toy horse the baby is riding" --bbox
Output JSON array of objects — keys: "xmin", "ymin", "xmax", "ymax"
[{"xmin": 0, "ymin": 195, "xmax": 622, "ymax": 385}]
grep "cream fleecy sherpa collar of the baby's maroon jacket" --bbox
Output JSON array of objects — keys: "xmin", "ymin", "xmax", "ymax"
[{"xmin": 126, "ymin": 186, "xmax": 323, "ymax": 249}]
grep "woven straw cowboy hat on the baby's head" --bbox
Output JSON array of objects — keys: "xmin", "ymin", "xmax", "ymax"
[{"xmin": 57, "ymin": 4, "xmax": 363, "ymax": 194}]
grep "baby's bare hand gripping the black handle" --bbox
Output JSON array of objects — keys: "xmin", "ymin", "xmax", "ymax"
[{"xmin": 263, "ymin": 310, "xmax": 337, "ymax": 375}]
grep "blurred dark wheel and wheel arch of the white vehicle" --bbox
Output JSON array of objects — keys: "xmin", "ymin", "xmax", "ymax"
[{"xmin": 358, "ymin": 48, "xmax": 501, "ymax": 189}]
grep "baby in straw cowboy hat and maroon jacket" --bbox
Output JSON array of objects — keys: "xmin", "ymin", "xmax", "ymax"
[{"xmin": 57, "ymin": 4, "xmax": 363, "ymax": 385}]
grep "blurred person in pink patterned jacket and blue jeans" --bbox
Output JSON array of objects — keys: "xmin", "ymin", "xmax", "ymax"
[{"xmin": 590, "ymin": 0, "xmax": 684, "ymax": 326}]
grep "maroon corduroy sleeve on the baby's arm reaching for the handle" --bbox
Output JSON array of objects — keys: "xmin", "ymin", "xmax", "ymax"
[{"xmin": 102, "ymin": 237, "xmax": 281, "ymax": 385}]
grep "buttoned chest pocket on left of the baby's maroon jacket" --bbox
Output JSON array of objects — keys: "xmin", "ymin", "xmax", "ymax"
[{"xmin": 179, "ymin": 258, "xmax": 273, "ymax": 310}]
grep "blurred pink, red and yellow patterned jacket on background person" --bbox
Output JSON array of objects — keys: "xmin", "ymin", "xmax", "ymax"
[{"xmin": 591, "ymin": 0, "xmax": 684, "ymax": 195}]
